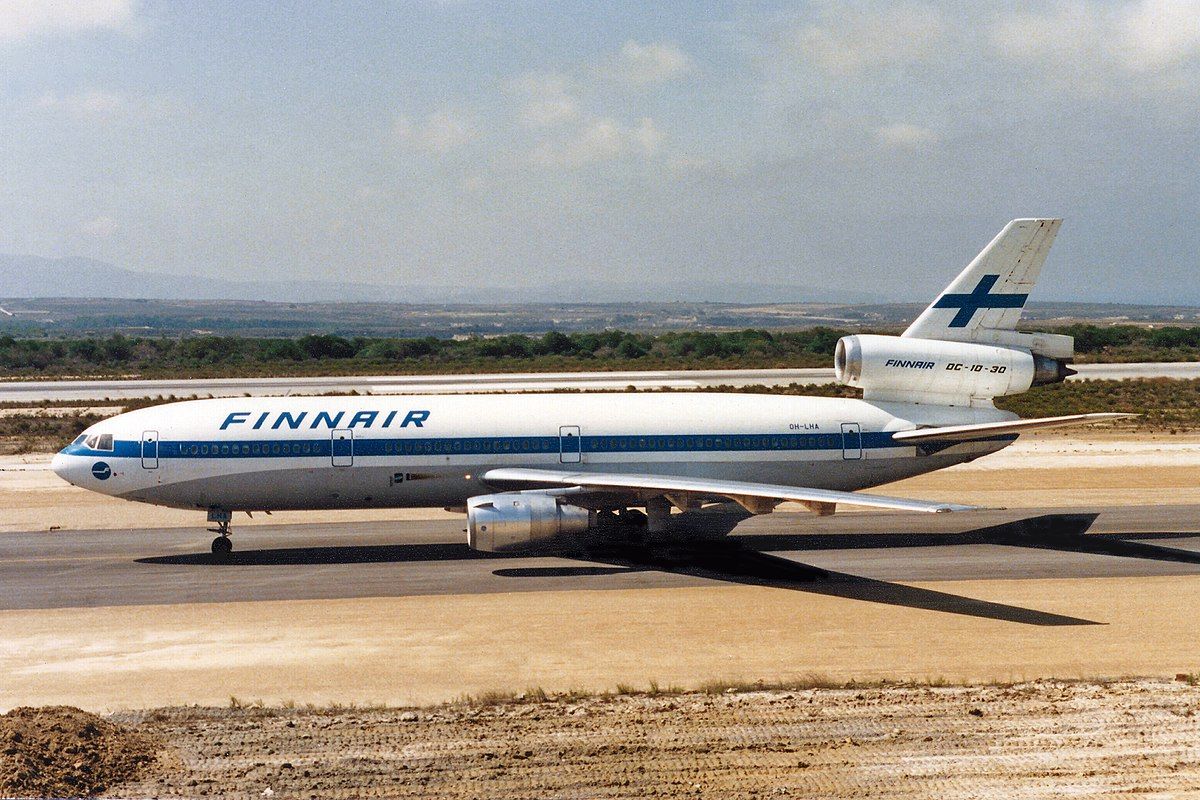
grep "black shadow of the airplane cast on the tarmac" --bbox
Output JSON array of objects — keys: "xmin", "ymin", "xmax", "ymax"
[{"xmin": 138, "ymin": 513, "xmax": 1200, "ymax": 626}]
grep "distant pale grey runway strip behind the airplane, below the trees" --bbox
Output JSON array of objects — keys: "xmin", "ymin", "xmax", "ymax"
[{"xmin": 0, "ymin": 361, "xmax": 1200, "ymax": 403}]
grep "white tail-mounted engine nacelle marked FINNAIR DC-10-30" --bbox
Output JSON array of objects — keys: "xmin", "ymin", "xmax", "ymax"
[{"xmin": 834, "ymin": 333, "xmax": 1072, "ymax": 405}]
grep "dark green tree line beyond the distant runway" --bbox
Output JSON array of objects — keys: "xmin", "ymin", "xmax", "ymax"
[{"xmin": 0, "ymin": 324, "xmax": 1200, "ymax": 377}]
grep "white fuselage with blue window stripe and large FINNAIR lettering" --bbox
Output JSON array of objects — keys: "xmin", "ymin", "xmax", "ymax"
[{"xmin": 53, "ymin": 393, "xmax": 1014, "ymax": 511}]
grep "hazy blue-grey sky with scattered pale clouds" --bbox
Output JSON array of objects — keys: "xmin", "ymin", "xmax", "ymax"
[{"xmin": 0, "ymin": 0, "xmax": 1200, "ymax": 303}]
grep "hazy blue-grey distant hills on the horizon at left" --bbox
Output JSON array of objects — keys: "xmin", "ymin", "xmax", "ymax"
[{"xmin": 0, "ymin": 254, "xmax": 886, "ymax": 305}]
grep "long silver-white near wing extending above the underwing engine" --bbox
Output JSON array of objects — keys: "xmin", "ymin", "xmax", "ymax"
[{"xmin": 484, "ymin": 467, "xmax": 974, "ymax": 515}]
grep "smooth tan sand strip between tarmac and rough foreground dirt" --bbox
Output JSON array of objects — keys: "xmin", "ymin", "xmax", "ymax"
[{"xmin": 0, "ymin": 576, "xmax": 1200, "ymax": 711}]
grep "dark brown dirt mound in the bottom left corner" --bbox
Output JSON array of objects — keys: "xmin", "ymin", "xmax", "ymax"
[{"xmin": 0, "ymin": 705, "xmax": 158, "ymax": 798}]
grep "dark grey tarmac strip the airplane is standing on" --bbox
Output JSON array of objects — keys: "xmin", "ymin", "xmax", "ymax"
[{"xmin": 7, "ymin": 506, "xmax": 1200, "ymax": 625}]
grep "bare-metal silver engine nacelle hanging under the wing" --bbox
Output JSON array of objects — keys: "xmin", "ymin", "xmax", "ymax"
[{"xmin": 467, "ymin": 492, "xmax": 594, "ymax": 553}]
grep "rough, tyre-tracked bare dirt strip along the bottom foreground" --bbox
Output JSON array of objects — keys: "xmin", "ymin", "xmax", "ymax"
[{"xmin": 105, "ymin": 681, "xmax": 1200, "ymax": 799}]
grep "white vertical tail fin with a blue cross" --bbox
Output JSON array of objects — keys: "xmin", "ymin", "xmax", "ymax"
[{"xmin": 902, "ymin": 219, "xmax": 1062, "ymax": 342}]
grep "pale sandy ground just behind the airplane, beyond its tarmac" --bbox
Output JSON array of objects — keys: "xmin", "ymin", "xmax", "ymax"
[{"xmin": 0, "ymin": 433, "xmax": 1200, "ymax": 531}]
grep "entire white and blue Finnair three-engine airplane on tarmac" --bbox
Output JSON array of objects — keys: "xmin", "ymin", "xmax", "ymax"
[{"xmin": 52, "ymin": 218, "xmax": 1130, "ymax": 555}]
